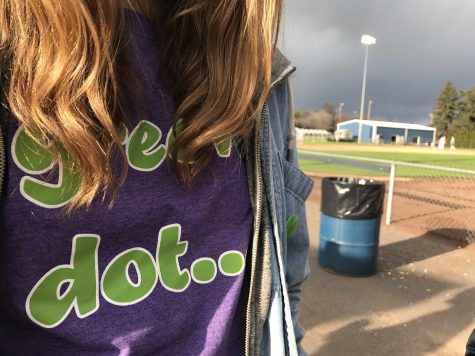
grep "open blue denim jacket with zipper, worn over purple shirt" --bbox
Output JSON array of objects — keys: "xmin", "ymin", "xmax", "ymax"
[{"xmin": 0, "ymin": 51, "xmax": 313, "ymax": 356}]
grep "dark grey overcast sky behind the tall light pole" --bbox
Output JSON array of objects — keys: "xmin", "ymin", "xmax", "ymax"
[{"xmin": 280, "ymin": 0, "xmax": 475, "ymax": 124}]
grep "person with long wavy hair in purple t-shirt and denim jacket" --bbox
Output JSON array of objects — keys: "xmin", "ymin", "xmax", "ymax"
[{"xmin": 0, "ymin": 0, "xmax": 312, "ymax": 355}]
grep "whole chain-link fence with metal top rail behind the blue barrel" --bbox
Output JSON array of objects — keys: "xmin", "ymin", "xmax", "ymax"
[{"xmin": 299, "ymin": 151, "xmax": 475, "ymax": 245}]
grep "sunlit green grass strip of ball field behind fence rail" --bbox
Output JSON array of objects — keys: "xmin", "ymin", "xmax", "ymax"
[{"xmin": 299, "ymin": 142, "xmax": 475, "ymax": 178}]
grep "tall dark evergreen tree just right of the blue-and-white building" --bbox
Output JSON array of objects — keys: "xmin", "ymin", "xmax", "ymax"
[{"xmin": 432, "ymin": 82, "xmax": 459, "ymax": 136}]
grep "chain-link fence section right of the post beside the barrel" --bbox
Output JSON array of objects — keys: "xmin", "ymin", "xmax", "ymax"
[{"xmin": 391, "ymin": 166, "xmax": 475, "ymax": 243}]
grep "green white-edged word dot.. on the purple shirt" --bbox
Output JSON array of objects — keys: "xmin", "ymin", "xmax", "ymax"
[{"xmin": 25, "ymin": 224, "xmax": 249, "ymax": 328}]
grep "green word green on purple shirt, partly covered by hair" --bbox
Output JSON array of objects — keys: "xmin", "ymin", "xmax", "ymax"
[{"xmin": 12, "ymin": 120, "xmax": 232, "ymax": 209}]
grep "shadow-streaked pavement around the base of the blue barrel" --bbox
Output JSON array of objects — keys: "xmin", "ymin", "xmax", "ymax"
[{"xmin": 300, "ymin": 179, "xmax": 475, "ymax": 356}]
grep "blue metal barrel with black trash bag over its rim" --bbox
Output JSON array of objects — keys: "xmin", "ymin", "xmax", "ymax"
[{"xmin": 318, "ymin": 178, "xmax": 385, "ymax": 276}]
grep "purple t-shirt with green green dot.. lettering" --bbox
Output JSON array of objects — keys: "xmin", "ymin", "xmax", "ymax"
[{"xmin": 0, "ymin": 12, "xmax": 253, "ymax": 355}]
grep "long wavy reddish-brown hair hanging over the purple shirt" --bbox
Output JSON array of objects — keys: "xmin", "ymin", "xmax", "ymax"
[{"xmin": 0, "ymin": 0, "xmax": 282, "ymax": 208}]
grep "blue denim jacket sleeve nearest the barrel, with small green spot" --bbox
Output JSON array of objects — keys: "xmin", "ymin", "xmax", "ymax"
[{"xmin": 282, "ymin": 82, "xmax": 314, "ymax": 355}]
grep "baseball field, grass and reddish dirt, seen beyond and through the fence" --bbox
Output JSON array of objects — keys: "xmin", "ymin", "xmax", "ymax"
[{"xmin": 298, "ymin": 141, "xmax": 475, "ymax": 245}]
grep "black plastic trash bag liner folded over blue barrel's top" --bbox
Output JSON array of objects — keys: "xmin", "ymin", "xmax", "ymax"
[{"xmin": 321, "ymin": 177, "xmax": 385, "ymax": 220}]
